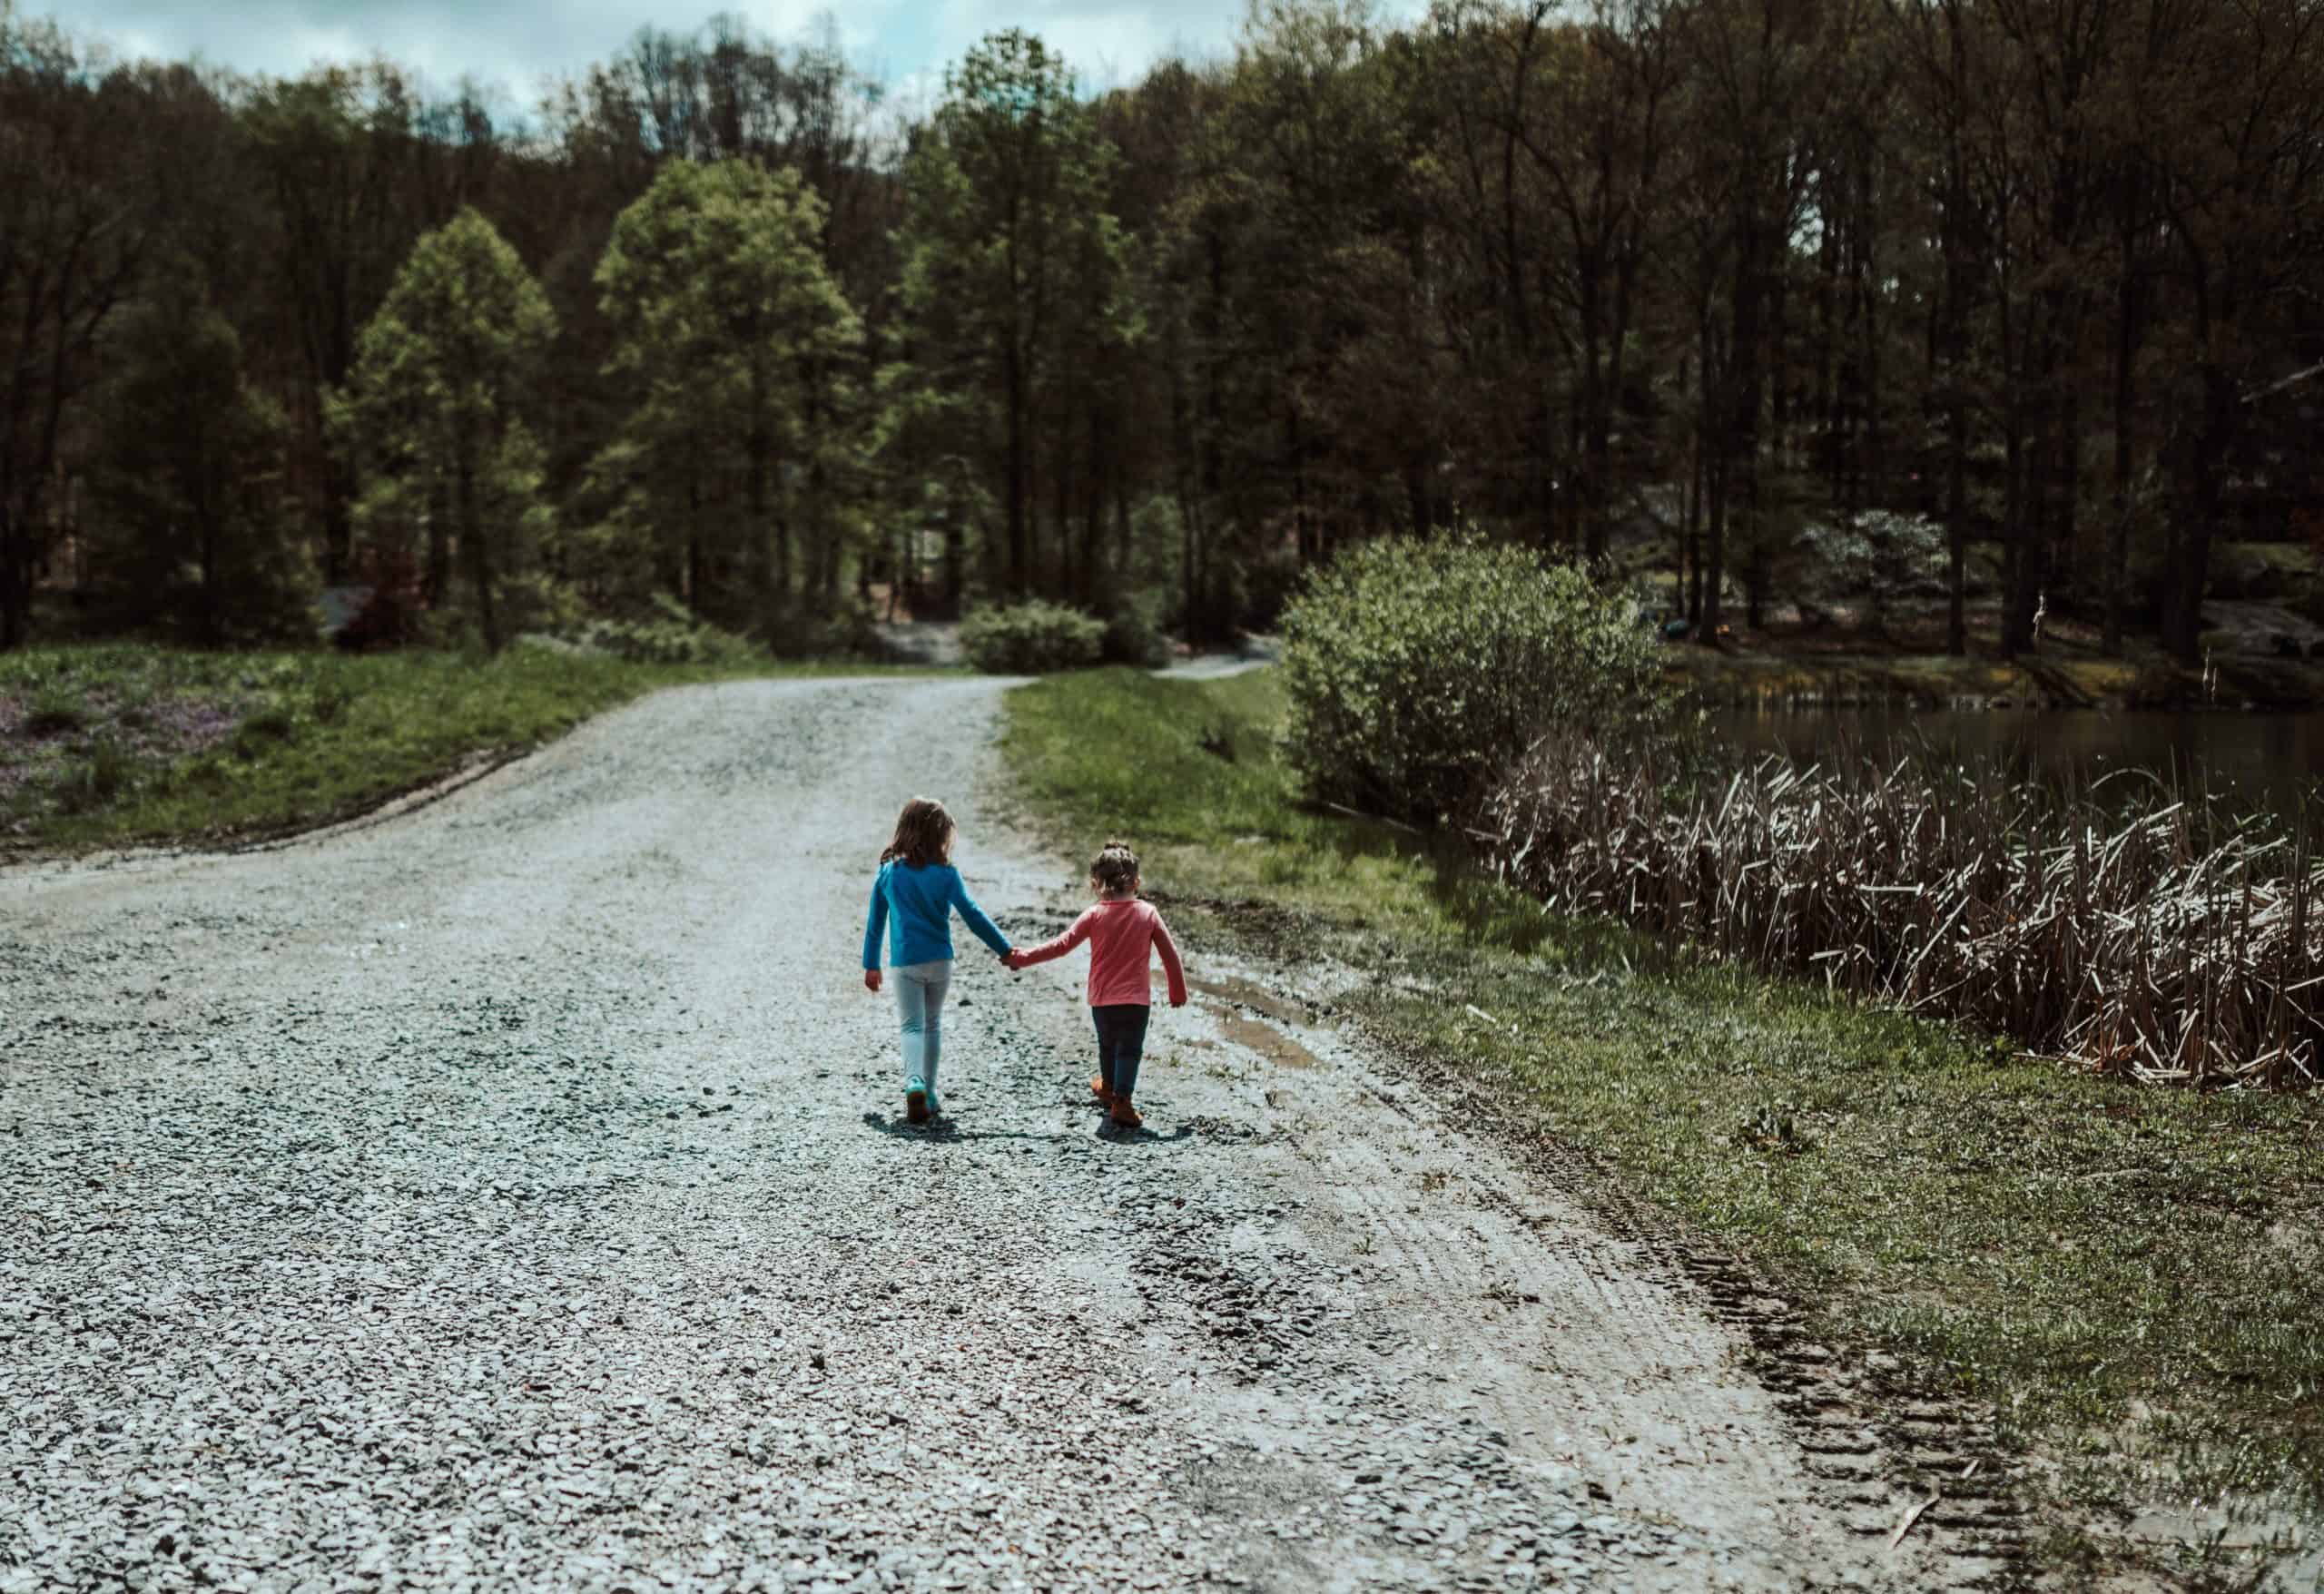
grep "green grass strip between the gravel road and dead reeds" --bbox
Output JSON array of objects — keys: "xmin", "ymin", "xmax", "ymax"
[{"xmin": 1004, "ymin": 672, "xmax": 2324, "ymax": 1508}]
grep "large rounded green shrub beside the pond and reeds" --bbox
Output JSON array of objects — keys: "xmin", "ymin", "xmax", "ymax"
[{"xmin": 1283, "ymin": 536, "xmax": 1669, "ymax": 822}]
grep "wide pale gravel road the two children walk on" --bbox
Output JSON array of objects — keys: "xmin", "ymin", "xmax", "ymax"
[{"xmin": 0, "ymin": 678, "xmax": 1996, "ymax": 1589}]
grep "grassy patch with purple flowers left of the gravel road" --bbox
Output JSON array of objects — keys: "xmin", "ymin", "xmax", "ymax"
[{"xmin": 0, "ymin": 644, "xmax": 943, "ymax": 852}]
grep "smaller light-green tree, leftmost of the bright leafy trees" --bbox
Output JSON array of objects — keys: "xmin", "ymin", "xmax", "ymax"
[{"xmin": 335, "ymin": 209, "xmax": 556, "ymax": 651}]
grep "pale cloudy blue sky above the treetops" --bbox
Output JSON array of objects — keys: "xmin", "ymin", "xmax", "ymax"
[{"xmin": 32, "ymin": 0, "xmax": 1423, "ymax": 104}]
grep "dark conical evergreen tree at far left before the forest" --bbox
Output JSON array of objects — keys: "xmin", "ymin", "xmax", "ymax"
[{"xmin": 91, "ymin": 262, "xmax": 316, "ymax": 644}]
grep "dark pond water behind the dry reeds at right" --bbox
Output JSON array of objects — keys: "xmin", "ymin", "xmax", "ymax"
[{"xmin": 1710, "ymin": 706, "xmax": 2324, "ymax": 825}]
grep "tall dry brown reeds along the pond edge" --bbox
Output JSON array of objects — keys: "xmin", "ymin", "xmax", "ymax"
[{"xmin": 1471, "ymin": 739, "xmax": 2324, "ymax": 1087}]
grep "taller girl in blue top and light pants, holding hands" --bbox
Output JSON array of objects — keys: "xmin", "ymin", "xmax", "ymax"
[{"xmin": 864, "ymin": 797, "xmax": 1009, "ymax": 1125}]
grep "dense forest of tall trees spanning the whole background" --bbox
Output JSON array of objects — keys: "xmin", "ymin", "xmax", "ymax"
[{"xmin": 0, "ymin": 0, "xmax": 2324, "ymax": 660}]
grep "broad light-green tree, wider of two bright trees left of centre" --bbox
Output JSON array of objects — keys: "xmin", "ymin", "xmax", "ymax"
[{"xmin": 593, "ymin": 161, "xmax": 862, "ymax": 639}]
